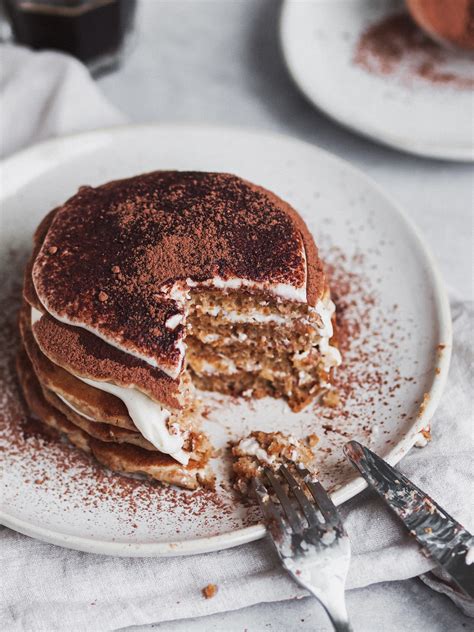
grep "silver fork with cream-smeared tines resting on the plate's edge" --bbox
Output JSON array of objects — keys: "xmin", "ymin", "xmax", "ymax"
[{"xmin": 252, "ymin": 462, "xmax": 352, "ymax": 632}]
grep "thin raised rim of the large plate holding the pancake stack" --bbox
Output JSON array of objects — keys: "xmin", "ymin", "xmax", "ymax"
[{"xmin": 0, "ymin": 124, "xmax": 452, "ymax": 557}]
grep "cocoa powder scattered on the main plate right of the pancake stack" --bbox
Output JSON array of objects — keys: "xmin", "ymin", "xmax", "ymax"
[{"xmin": 313, "ymin": 227, "xmax": 416, "ymax": 478}]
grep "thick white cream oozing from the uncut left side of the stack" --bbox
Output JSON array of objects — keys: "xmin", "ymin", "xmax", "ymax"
[{"xmin": 31, "ymin": 307, "xmax": 189, "ymax": 465}]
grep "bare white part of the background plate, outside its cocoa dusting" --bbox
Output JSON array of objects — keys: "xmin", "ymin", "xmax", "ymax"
[{"xmin": 280, "ymin": 0, "xmax": 474, "ymax": 161}]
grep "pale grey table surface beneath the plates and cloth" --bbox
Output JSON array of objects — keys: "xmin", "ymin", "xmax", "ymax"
[{"xmin": 98, "ymin": 0, "xmax": 474, "ymax": 632}]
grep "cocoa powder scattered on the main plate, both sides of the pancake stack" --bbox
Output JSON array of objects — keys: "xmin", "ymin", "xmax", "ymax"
[{"xmin": 0, "ymin": 225, "xmax": 422, "ymax": 537}]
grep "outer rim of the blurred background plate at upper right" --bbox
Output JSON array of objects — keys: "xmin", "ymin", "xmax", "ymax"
[{"xmin": 279, "ymin": 0, "xmax": 474, "ymax": 162}]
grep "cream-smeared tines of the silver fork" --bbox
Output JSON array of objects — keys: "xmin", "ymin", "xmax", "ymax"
[{"xmin": 253, "ymin": 464, "xmax": 344, "ymax": 543}]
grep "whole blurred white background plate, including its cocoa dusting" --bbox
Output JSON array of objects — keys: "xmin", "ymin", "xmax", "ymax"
[{"xmin": 280, "ymin": 0, "xmax": 474, "ymax": 161}]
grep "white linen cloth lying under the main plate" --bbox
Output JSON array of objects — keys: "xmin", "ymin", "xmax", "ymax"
[{"xmin": 0, "ymin": 46, "xmax": 474, "ymax": 631}]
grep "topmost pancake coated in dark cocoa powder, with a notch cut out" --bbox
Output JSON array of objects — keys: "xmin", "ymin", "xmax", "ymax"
[{"xmin": 32, "ymin": 171, "xmax": 324, "ymax": 377}]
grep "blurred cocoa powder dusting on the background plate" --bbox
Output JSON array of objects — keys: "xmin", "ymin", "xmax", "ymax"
[{"xmin": 353, "ymin": 13, "xmax": 474, "ymax": 90}]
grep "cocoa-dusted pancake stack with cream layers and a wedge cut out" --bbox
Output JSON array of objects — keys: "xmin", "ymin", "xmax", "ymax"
[{"xmin": 18, "ymin": 171, "xmax": 340, "ymax": 489}]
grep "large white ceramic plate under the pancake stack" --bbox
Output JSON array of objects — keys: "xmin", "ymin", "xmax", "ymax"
[{"xmin": 0, "ymin": 126, "xmax": 451, "ymax": 556}]
